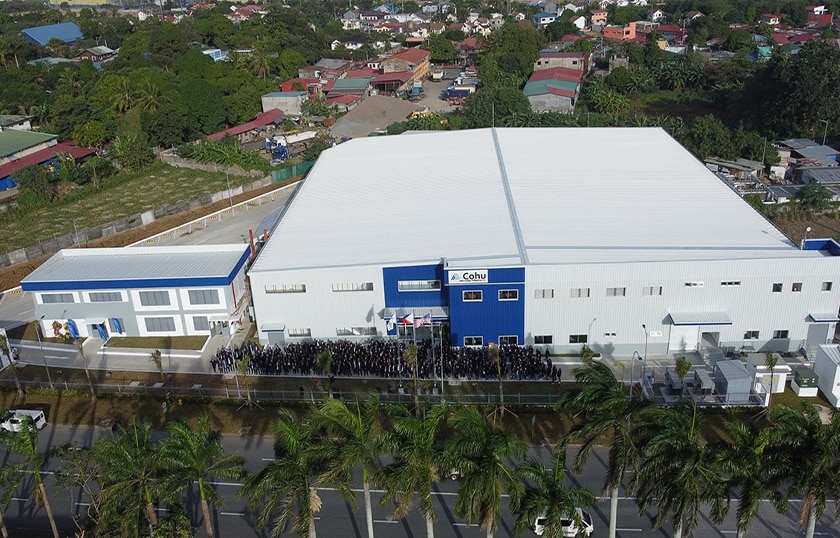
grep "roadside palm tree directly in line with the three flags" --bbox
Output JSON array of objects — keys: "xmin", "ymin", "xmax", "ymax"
[{"xmin": 382, "ymin": 404, "xmax": 446, "ymax": 538}]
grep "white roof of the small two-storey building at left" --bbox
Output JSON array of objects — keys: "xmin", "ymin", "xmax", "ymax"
[{"xmin": 22, "ymin": 244, "xmax": 250, "ymax": 282}]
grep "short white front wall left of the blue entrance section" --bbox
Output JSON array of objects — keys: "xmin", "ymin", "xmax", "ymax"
[{"xmin": 250, "ymin": 266, "xmax": 386, "ymax": 344}]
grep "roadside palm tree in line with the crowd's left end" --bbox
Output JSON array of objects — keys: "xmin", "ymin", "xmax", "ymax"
[{"xmin": 158, "ymin": 415, "xmax": 245, "ymax": 537}]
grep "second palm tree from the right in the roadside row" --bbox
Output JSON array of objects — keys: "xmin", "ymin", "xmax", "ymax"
[{"xmin": 714, "ymin": 421, "xmax": 791, "ymax": 538}]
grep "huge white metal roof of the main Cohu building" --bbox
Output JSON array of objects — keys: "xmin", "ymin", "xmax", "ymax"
[{"xmin": 251, "ymin": 128, "xmax": 808, "ymax": 272}]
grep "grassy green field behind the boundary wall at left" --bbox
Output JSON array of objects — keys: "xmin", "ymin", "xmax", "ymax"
[{"xmin": 0, "ymin": 161, "xmax": 260, "ymax": 252}]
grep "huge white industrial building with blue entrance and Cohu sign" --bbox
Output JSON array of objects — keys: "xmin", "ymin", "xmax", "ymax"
[{"xmin": 248, "ymin": 128, "xmax": 840, "ymax": 355}]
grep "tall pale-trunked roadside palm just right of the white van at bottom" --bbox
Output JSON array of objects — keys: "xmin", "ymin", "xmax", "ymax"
[{"xmin": 556, "ymin": 361, "xmax": 651, "ymax": 538}]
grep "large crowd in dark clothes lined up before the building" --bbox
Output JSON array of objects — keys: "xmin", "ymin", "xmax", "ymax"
[{"xmin": 210, "ymin": 339, "xmax": 561, "ymax": 381}]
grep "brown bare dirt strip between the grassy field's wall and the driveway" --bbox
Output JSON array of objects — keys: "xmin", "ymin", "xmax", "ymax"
[{"xmin": 0, "ymin": 181, "xmax": 293, "ymax": 290}]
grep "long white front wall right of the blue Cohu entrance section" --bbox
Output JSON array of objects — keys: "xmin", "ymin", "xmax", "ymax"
[{"xmin": 525, "ymin": 257, "xmax": 840, "ymax": 355}]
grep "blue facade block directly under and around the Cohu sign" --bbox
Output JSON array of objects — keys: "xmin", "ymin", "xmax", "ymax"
[{"xmin": 447, "ymin": 267, "xmax": 525, "ymax": 346}]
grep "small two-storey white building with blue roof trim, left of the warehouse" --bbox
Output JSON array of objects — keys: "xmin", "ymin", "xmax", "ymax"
[{"xmin": 21, "ymin": 244, "xmax": 251, "ymax": 340}]
